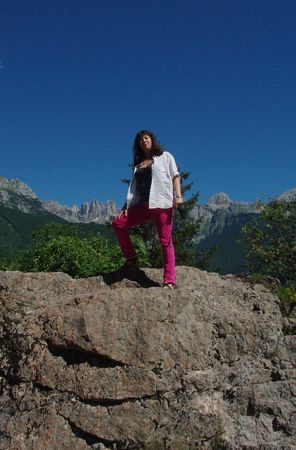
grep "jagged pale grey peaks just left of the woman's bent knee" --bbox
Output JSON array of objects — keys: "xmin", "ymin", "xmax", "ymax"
[{"xmin": 42, "ymin": 200, "xmax": 119, "ymax": 224}]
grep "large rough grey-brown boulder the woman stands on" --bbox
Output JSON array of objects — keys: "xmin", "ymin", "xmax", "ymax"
[{"xmin": 0, "ymin": 267, "xmax": 296, "ymax": 450}]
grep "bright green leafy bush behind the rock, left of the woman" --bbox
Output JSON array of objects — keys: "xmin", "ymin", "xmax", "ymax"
[{"xmin": 2, "ymin": 222, "xmax": 148, "ymax": 277}]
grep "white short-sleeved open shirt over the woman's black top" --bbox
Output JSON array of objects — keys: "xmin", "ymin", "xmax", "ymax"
[{"xmin": 126, "ymin": 152, "xmax": 180, "ymax": 209}]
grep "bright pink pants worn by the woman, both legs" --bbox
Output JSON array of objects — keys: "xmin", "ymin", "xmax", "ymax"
[{"xmin": 112, "ymin": 202, "xmax": 176, "ymax": 283}]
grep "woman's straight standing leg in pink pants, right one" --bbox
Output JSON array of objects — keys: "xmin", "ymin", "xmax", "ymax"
[{"xmin": 150, "ymin": 208, "xmax": 176, "ymax": 283}]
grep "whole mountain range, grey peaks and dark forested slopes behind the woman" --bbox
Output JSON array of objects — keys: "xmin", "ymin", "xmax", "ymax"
[{"xmin": 0, "ymin": 176, "xmax": 296, "ymax": 273}]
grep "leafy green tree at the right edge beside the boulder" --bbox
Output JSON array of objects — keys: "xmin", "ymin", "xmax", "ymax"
[{"xmin": 243, "ymin": 198, "xmax": 296, "ymax": 283}]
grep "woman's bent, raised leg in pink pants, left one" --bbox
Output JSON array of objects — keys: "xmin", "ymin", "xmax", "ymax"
[{"xmin": 112, "ymin": 203, "xmax": 149, "ymax": 259}]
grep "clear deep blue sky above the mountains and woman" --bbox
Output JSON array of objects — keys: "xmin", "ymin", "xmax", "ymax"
[{"xmin": 0, "ymin": 0, "xmax": 296, "ymax": 205}]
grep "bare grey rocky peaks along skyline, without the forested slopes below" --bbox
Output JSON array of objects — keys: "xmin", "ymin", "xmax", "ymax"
[{"xmin": 0, "ymin": 176, "xmax": 296, "ymax": 229}]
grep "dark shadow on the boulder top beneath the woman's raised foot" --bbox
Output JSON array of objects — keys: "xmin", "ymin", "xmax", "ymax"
[{"xmin": 99, "ymin": 268, "xmax": 161, "ymax": 288}]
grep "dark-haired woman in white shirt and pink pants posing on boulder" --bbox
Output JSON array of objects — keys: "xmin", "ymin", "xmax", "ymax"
[{"xmin": 112, "ymin": 130, "xmax": 183, "ymax": 289}]
